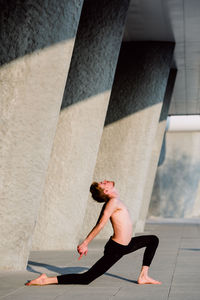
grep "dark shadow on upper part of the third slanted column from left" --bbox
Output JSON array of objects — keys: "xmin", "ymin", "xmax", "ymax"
[{"xmin": 105, "ymin": 42, "xmax": 174, "ymax": 126}]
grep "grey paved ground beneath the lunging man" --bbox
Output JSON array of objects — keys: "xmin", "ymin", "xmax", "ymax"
[{"xmin": 0, "ymin": 223, "xmax": 200, "ymax": 300}]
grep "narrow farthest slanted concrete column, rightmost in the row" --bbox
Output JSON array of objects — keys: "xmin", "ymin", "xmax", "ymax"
[{"xmin": 136, "ymin": 69, "xmax": 177, "ymax": 232}]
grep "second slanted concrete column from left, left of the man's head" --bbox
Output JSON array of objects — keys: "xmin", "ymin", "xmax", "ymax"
[{"xmin": 33, "ymin": 0, "xmax": 129, "ymax": 249}]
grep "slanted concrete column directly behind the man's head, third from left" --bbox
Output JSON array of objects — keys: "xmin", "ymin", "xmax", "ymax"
[{"xmin": 82, "ymin": 42, "xmax": 174, "ymax": 238}]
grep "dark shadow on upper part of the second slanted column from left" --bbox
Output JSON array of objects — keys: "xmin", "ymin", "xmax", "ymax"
[{"xmin": 61, "ymin": 0, "xmax": 129, "ymax": 110}]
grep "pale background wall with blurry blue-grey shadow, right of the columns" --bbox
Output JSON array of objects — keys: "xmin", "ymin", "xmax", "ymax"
[{"xmin": 148, "ymin": 131, "xmax": 200, "ymax": 218}]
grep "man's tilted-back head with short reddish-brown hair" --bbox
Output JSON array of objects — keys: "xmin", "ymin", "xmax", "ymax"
[{"xmin": 90, "ymin": 180, "xmax": 115, "ymax": 202}]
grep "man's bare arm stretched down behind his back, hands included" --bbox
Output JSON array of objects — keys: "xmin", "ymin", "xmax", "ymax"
[{"xmin": 77, "ymin": 199, "xmax": 116, "ymax": 259}]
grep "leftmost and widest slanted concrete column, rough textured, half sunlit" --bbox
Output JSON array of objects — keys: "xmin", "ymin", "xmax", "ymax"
[{"xmin": 0, "ymin": 0, "xmax": 82, "ymax": 270}]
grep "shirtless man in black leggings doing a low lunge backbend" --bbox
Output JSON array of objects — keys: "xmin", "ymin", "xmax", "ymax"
[{"xmin": 26, "ymin": 180, "xmax": 161, "ymax": 286}]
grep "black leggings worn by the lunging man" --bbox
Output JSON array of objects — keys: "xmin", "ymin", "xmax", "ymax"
[{"xmin": 57, "ymin": 235, "xmax": 159, "ymax": 284}]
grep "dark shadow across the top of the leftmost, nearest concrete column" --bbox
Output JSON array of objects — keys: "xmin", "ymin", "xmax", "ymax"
[{"xmin": 0, "ymin": 0, "xmax": 83, "ymax": 66}]
